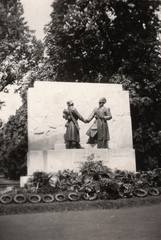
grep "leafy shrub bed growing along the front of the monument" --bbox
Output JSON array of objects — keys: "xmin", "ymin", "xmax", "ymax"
[{"xmin": 20, "ymin": 161, "xmax": 161, "ymax": 200}]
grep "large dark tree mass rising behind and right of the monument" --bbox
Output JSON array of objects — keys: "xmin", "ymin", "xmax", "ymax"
[{"xmin": 46, "ymin": 0, "xmax": 161, "ymax": 168}]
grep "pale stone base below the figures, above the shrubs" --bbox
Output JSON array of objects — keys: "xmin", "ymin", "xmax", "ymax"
[{"xmin": 28, "ymin": 148, "xmax": 136, "ymax": 175}]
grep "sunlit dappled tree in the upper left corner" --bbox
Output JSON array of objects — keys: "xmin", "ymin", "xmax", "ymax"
[{"xmin": 0, "ymin": 0, "xmax": 44, "ymax": 91}]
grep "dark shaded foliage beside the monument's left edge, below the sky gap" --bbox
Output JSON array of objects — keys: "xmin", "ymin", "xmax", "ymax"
[{"xmin": 0, "ymin": 105, "xmax": 28, "ymax": 178}]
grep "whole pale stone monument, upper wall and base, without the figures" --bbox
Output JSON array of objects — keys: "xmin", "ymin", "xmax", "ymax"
[{"xmin": 21, "ymin": 81, "xmax": 136, "ymax": 186}]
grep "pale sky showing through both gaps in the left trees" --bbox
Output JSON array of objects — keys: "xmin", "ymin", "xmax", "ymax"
[{"xmin": 0, "ymin": 0, "xmax": 54, "ymax": 122}]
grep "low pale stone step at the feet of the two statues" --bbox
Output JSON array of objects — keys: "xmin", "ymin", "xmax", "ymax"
[{"xmin": 53, "ymin": 143, "xmax": 117, "ymax": 150}]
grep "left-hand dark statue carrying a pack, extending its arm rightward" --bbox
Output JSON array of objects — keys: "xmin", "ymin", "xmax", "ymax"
[{"xmin": 63, "ymin": 100, "xmax": 85, "ymax": 149}]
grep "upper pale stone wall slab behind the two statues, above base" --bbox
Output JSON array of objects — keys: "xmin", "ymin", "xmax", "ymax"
[{"xmin": 28, "ymin": 81, "xmax": 132, "ymax": 151}]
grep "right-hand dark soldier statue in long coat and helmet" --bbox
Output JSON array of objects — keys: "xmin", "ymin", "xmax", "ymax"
[{"xmin": 86, "ymin": 98, "xmax": 112, "ymax": 148}]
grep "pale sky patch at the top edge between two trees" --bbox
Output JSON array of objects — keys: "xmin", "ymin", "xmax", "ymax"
[{"xmin": 20, "ymin": 0, "xmax": 53, "ymax": 40}]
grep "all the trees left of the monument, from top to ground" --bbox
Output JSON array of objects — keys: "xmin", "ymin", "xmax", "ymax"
[{"xmin": 0, "ymin": 0, "xmax": 44, "ymax": 178}]
